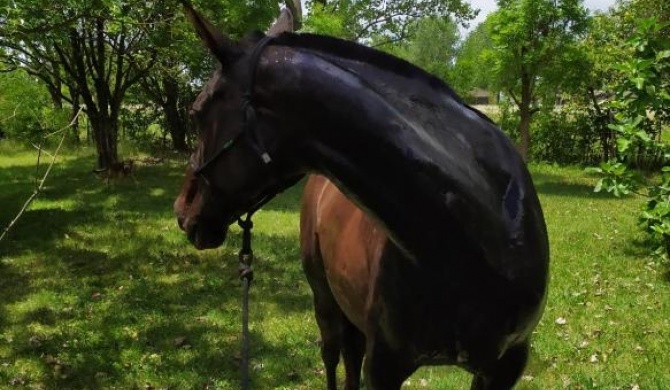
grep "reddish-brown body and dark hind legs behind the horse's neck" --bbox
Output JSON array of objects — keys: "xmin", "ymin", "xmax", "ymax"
[{"xmin": 300, "ymin": 175, "xmax": 392, "ymax": 390}]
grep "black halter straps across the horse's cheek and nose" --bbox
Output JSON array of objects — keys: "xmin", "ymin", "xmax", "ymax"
[{"xmin": 191, "ymin": 36, "xmax": 274, "ymax": 176}]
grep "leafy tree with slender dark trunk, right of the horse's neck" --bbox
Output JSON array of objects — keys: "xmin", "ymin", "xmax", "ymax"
[{"xmin": 490, "ymin": 0, "xmax": 588, "ymax": 160}]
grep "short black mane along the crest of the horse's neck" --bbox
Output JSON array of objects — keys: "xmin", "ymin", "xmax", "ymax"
[{"xmin": 275, "ymin": 33, "xmax": 493, "ymax": 123}]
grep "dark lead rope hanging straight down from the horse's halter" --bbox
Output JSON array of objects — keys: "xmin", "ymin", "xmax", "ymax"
[{"xmin": 237, "ymin": 213, "xmax": 254, "ymax": 390}]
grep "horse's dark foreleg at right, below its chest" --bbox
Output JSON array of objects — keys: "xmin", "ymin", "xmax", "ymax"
[{"xmin": 470, "ymin": 342, "xmax": 530, "ymax": 390}]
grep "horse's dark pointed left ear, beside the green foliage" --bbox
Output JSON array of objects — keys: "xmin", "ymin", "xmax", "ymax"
[{"xmin": 181, "ymin": 0, "xmax": 242, "ymax": 68}]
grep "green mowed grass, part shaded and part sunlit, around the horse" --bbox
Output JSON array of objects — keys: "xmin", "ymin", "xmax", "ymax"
[{"xmin": 0, "ymin": 141, "xmax": 670, "ymax": 389}]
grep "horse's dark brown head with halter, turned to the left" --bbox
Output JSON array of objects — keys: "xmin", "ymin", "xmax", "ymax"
[{"xmin": 174, "ymin": 3, "xmax": 295, "ymax": 249}]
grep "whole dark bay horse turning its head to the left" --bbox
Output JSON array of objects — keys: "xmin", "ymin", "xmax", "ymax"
[{"xmin": 174, "ymin": 1, "xmax": 549, "ymax": 390}]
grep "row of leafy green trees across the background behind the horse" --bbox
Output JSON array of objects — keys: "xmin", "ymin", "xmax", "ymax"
[{"xmin": 0, "ymin": 0, "xmax": 670, "ymax": 168}]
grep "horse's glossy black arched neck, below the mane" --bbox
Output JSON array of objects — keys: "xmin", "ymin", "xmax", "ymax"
[{"xmin": 261, "ymin": 49, "xmax": 548, "ymax": 296}]
